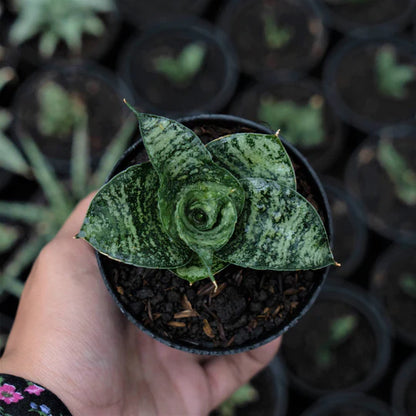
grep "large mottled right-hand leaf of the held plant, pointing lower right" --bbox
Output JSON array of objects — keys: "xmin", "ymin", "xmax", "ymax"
[{"xmin": 216, "ymin": 178, "xmax": 335, "ymax": 271}]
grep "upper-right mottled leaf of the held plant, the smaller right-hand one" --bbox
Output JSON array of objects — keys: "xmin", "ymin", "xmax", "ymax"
[{"xmin": 206, "ymin": 133, "xmax": 296, "ymax": 189}]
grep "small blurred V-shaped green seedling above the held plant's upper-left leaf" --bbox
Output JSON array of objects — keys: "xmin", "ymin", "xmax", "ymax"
[{"xmin": 154, "ymin": 42, "xmax": 206, "ymax": 86}]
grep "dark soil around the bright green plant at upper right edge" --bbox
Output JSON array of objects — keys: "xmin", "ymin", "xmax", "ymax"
[{"xmin": 335, "ymin": 42, "xmax": 416, "ymax": 125}]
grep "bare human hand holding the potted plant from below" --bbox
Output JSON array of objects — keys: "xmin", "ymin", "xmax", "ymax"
[{"xmin": 0, "ymin": 196, "xmax": 280, "ymax": 416}]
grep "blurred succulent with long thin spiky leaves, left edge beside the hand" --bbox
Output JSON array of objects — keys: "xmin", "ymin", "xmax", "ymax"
[{"xmin": 0, "ymin": 112, "xmax": 135, "ymax": 296}]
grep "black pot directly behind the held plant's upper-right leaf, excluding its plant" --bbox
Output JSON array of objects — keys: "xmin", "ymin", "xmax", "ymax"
[{"xmin": 230, "ymin": 78, "xmax": 344, "ymax": 172}]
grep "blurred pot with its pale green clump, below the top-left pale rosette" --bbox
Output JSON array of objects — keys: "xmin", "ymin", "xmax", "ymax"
[{"xmin": 12, "ymin": 64, "xmax": 132, "ymax": 175}]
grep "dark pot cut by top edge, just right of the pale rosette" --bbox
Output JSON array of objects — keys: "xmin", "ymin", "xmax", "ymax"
[{"xmin": 117, "ymin": 0, "xmax": 211, "ymax": 29}]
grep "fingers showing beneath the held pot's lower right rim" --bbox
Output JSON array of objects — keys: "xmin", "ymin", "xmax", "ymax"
[{"xmin": 202, "ymin": 337, "xmax": 281, "ymax": 408}]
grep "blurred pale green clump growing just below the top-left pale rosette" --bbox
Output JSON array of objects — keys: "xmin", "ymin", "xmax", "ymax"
[{"xmin": 37, "ymin": 81, "xmax": 87, "ymax": 138}]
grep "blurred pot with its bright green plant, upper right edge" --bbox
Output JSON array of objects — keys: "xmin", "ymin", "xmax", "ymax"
[{"xmin": 324, "ymin": 38, "xmax": 416, "ymax": 133}]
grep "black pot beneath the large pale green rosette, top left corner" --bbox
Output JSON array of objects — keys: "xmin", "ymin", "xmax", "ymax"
[{"xmin": 7, "ymin": 2, "xmax": 121, "ymax": 68}]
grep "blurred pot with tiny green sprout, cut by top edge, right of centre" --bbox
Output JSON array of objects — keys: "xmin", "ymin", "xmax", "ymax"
[{"xmin": 220, "ymin": 0, "xmax": 326, "ymax": 78}]
